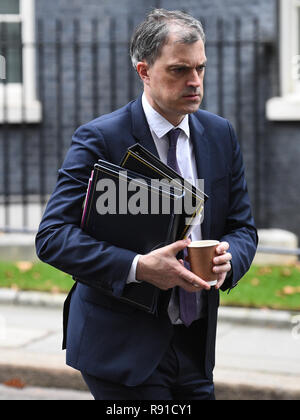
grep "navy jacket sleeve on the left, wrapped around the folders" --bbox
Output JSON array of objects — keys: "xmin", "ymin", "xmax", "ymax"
[{"xmin": 36, "ymin": 124, "xmax": 136, "ymax": 297}]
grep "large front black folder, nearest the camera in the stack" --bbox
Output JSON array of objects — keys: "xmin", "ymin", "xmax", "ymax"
[{"xmin": 75, "ymin": 160, "xmax": 183, "ymax": 313}]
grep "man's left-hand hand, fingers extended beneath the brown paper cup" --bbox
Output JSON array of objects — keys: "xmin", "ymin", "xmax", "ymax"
[{"xmin": 136, "ymin": 239, "xmax": 210, "ymax": 292}]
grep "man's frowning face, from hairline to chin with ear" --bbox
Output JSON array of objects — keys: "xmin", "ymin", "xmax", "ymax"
[{"xmin": 137, "ymin": 34, "xmax": 206, "ymax": 126}]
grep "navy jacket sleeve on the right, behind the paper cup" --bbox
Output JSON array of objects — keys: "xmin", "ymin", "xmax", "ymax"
[{"xmin": 221, "ymin": 122, "xmax": 258, "ymax": 291}]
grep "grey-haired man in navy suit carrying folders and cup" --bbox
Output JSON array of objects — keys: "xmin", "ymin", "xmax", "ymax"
[{"xmin": 36, "ymin": 9, "xmax": 257, "ymax": 400}]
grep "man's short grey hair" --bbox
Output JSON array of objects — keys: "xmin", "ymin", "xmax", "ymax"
[{"xmin": 130, "ymin": 9, "xmax": 205, "ymax": 69}]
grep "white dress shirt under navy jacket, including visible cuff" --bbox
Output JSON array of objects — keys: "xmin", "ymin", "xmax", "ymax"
[{"xmin": 127, "ymin": 93, "xmax": 203, "ymax": 324}]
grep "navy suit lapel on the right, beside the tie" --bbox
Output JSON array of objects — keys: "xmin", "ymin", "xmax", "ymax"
[{"xmin": 189, "ymin": 114, "xmax": 211, "ymax": 239}]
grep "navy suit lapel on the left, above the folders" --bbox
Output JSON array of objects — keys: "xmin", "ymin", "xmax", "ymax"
[{"xmin": 131, "ymin": 96, "xmax": 159, "ymax": 158}]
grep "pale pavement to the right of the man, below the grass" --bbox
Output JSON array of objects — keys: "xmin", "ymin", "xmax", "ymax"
[{"xmin": 215, "ymin": 322, "xmax": 300, "ymax": 391}]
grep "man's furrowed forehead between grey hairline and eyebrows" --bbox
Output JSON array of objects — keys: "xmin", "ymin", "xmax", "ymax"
[{"xmin": 157, "ymin": 34, "xmax": 206, "ymax": 65}]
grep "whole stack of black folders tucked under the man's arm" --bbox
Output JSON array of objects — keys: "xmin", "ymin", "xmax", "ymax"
[{"xmin": 77, "ymin": 144, "xmax": 207, "ymax": 313}]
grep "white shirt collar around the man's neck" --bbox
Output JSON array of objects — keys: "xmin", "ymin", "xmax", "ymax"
[{"xmin": 142, "ymin": 93, "xmax": 190, "ymax": 139}]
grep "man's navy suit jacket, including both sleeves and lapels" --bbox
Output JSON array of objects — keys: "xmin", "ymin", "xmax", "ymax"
[{"xmin": 36, "ymin": 97, "xmax": 257, "ymax": 386}]
